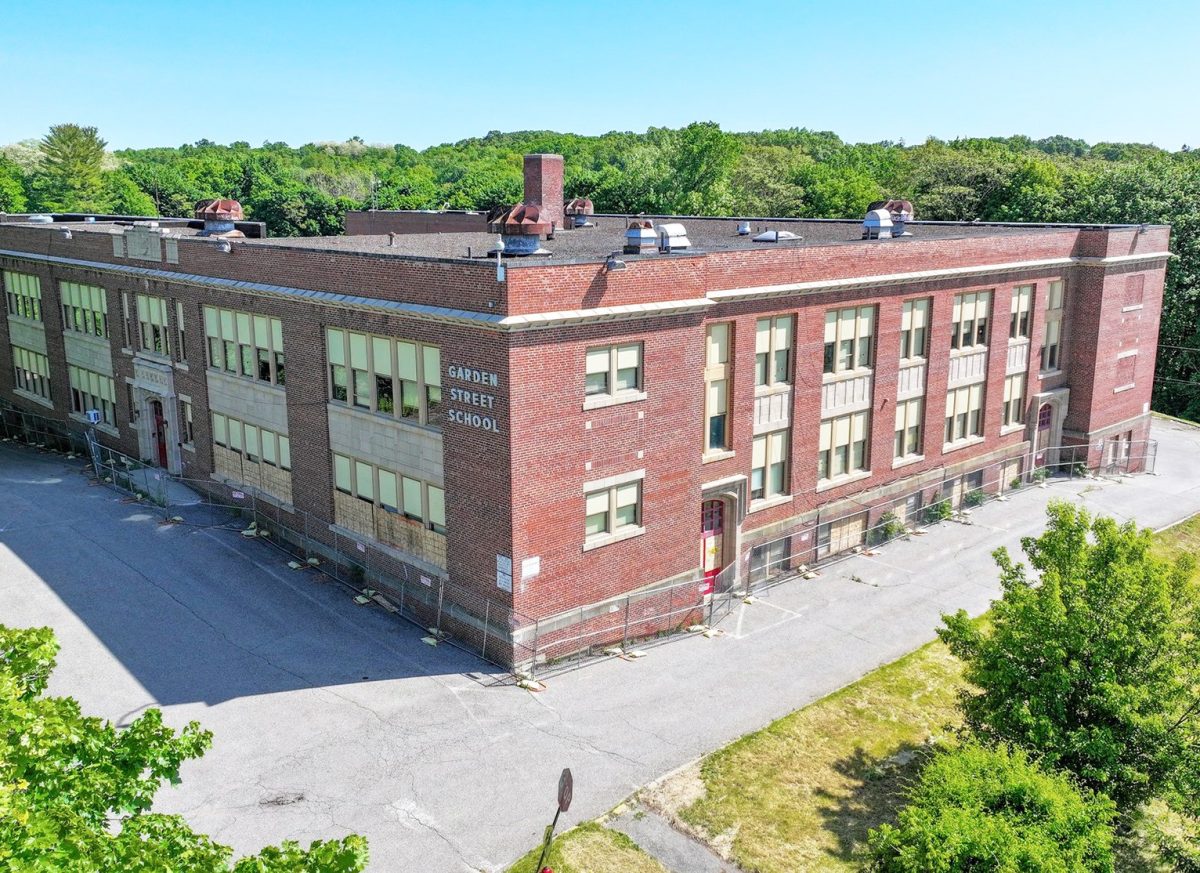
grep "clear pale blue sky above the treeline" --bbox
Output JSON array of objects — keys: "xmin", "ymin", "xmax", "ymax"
[{"xmin": 0, "ymin": 0, "xmax": 1200, "ymax": 149}]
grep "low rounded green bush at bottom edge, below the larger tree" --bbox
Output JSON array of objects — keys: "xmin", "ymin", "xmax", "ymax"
[{"xmin": 868, "ymin": 743, "xmax": 1115, "ymax": 873}]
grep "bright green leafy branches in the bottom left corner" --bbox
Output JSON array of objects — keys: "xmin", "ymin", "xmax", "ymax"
[{"xmin": 0, "ymin": 625, "xmax": 367, "ymax": 873}]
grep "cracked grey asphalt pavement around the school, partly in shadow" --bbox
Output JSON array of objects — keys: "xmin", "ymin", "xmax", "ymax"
[{"xmin": 0, "ymin": 421, "xmax": 1200, "ymax": 871}]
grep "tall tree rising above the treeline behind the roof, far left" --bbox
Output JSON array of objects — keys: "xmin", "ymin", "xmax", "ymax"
[{"xmin": 34, "ymin": 125, "xmax": 107, "ymax": 212}]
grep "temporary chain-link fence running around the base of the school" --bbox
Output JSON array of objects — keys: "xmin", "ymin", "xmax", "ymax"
[{"xmin": 0, "ymin": 398, "xmax": 1157, "ymax": 676}]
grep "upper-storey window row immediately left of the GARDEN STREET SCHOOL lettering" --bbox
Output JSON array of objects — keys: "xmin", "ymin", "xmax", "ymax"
[{"xmin": 325, "ymin": 327, "xmax": 443, "ymax": 425}]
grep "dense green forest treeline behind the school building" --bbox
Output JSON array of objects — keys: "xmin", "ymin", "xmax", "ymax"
[{"xmin": 0, "ymin": 124, "xmax": 1200, "ymax": 420}]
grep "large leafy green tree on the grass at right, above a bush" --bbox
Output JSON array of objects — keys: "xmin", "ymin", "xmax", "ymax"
[{"xmin": 938, "ymin": 501, "xmax": 1200, "ymax": 811}]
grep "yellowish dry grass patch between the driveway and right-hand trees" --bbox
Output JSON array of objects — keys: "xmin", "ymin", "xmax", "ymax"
[{"xmin": 672, "ymin": 643, "xmax": 964, "ymax": 873}]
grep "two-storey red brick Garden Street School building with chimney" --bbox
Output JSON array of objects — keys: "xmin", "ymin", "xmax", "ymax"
[{"xmin": 0, "ymin": 155, "xmax": 1169, "ymax": 661}]
